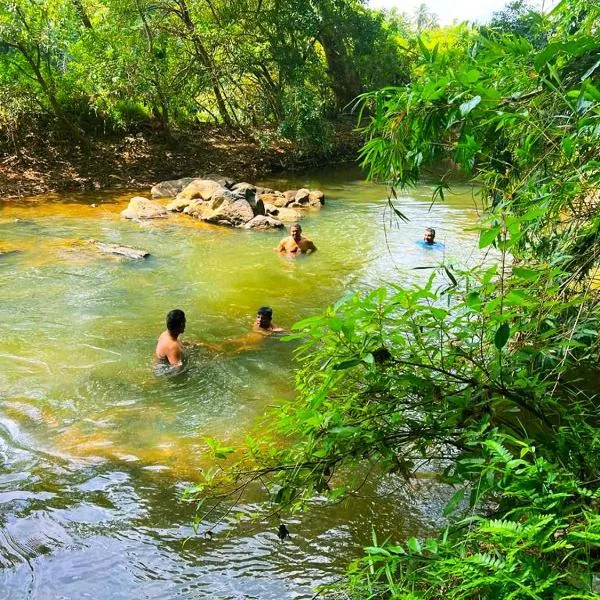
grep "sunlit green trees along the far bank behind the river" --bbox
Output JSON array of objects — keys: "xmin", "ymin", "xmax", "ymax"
[{"xmin": 0, "ymin": 0, "xmax": 405, "ymax": 150}]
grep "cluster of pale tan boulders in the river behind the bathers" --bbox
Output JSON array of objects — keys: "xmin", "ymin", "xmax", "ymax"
[{"xmin": 121, "ymin": 175, "xmax": 325, "ymax": 230}]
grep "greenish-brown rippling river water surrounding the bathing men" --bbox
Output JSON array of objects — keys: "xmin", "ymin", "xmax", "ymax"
[{"xmin": 0, "ymin": 169, "xmax": 480, "ymax": 600}]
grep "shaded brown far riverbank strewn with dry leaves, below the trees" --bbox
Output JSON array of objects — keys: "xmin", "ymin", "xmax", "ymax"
[{"xmin": 0, "ymin": 124, "xmax": 361, "ymax": 200}]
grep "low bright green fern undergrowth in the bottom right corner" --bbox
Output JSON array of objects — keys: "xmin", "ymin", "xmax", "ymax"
[{"xmin": 350, "ymin": 431, "xmax": 600, "ymax": 599}]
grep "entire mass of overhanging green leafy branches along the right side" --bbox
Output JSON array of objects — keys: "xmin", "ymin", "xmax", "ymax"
[{"xmin": 186, "ymin": 1, "xmax": 600, "ymax": 599}]
